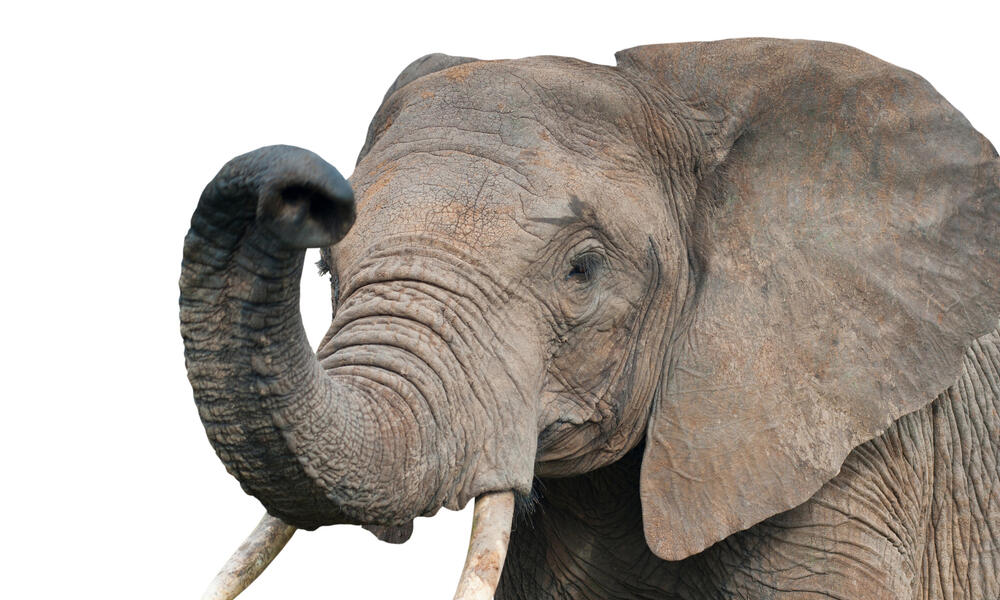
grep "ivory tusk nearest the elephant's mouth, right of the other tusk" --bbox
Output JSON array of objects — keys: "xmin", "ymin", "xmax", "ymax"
[{"xmin": 454, "ymin": 492, "xmax": 514, "ymax": 600}]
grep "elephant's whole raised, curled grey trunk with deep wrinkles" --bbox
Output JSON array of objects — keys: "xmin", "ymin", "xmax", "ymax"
[{"xmin": 180, "ymin": 146, "xmax": 537, "ymax": 529}]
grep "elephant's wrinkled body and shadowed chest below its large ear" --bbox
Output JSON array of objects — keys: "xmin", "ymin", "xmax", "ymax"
[{"xmin": 497, "ymin": 331, "xmax": 1000, "ymax": 600}]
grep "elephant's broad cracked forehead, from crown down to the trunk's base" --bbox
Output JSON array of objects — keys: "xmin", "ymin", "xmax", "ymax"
[{"xmin": 345, "ymin": 58, "xmax": 664, "ymax": 255}]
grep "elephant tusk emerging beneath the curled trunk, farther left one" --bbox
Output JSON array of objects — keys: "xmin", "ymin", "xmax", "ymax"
[{"xmin": 201, "ymin": 513, "xmax": 295, "ymax": 600}]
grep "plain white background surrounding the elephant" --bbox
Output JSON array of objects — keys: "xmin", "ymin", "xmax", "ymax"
[{"xmin": 0, "ymin": 0, "xmax": 1000, "ymax": 599}]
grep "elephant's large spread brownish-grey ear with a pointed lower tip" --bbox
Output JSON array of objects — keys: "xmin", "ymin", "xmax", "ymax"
[{"xmin": 617, "ymin": 39, "xmax": 1000, "ymax": 560}]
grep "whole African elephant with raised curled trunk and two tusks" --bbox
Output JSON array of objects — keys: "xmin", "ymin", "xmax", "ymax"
[{"xmin": 180, "ymin": 39, "xmax": 1000, "ymax": 600}]
